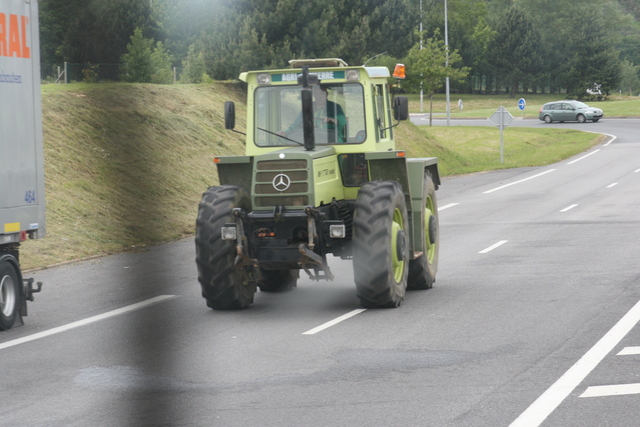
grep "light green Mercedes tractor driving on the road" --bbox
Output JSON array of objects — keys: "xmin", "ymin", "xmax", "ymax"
[{"xmin": 196, "ymin": 59, "xmax": 440, "ymax": 310}]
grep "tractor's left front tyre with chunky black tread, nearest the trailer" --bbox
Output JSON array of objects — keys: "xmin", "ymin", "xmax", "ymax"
[{"xmin": 196, "ymin": 185, "xmax": 256, "ymax": 310}]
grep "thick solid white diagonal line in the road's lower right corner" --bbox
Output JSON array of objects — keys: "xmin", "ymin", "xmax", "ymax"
[{"xmin": 509, "ymin": 301, "xmax": 640, "ymax": 427}]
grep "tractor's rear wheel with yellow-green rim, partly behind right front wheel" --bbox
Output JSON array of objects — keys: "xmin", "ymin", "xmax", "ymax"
[{"xmin": 407, "ymin": 172, "xmax": 440, "ymax": 289}]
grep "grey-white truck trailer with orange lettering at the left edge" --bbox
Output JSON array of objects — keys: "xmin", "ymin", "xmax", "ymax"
[{"xmin": 0, "ymin": 0, "xmax": 45, "ymax": 330}]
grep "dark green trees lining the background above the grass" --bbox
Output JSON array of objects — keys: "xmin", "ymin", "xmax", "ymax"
[{"xmin": 40, "ymin": 0, "xmax": 640, "ymax": 97}]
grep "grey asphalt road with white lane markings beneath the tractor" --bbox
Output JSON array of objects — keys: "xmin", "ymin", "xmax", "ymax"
[{"xmin": 0, "ymin": 116, "xmax": 640, "ymax": 427}]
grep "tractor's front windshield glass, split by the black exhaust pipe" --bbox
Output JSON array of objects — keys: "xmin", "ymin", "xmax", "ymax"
[{"xmin": 254, "ymin": 83, "xmax": 366, "ymax": 147}]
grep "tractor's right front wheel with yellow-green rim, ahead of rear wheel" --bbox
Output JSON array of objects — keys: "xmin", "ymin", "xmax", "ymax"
[{"xmin": 353, "ymin": 181, "xmax": 409, "ymax": 308}]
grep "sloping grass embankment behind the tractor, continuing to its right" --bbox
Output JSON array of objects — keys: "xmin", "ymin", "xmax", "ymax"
[{"xmin": 21, "ymin": 83, "xmax": 598, "ymax": 269}]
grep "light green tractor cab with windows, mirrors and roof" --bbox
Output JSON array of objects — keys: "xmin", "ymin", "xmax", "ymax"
[{"xmin": 226, "ymin": 58, "xmax": 408, "ymax": 155}]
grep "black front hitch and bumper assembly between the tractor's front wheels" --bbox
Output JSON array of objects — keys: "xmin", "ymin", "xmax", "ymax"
[{"xmin": 222, "ymin": 207, "xmax": 335, "ymax": 281}]
